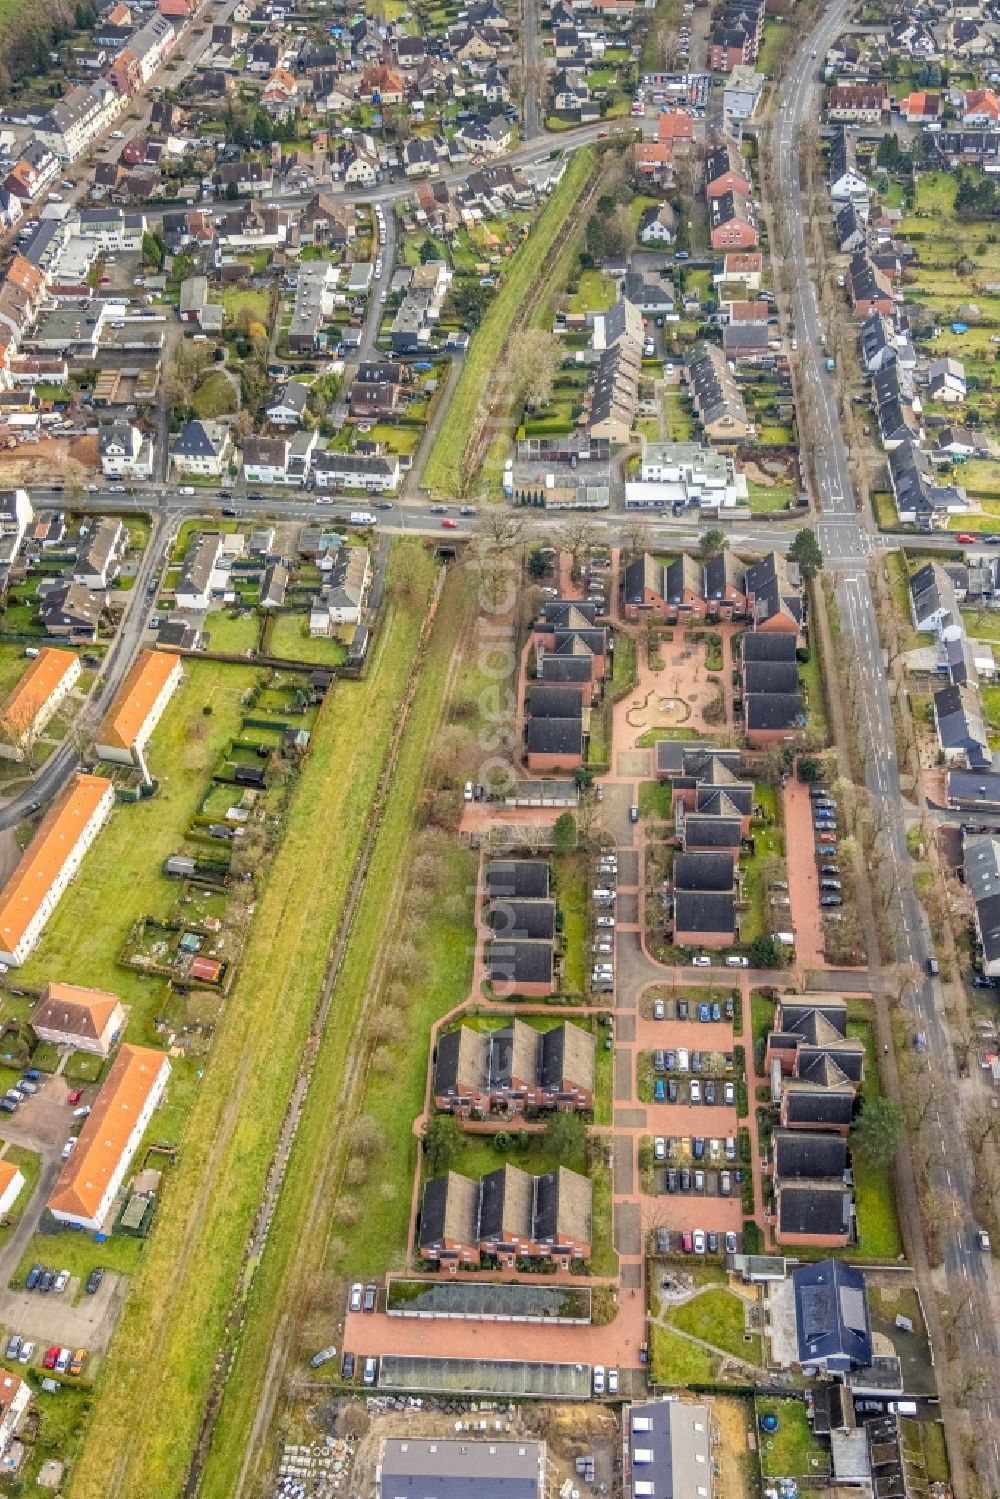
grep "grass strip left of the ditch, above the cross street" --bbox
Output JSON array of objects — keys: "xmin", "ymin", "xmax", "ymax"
[{"xmin": 423, "ymin": 148, "xmax": 594, "ymax": 496}]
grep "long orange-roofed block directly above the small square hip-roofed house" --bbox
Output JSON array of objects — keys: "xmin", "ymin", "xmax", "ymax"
[{"xmin": 0, "ymin": 775, "xmax": 114, "ymax": 968}]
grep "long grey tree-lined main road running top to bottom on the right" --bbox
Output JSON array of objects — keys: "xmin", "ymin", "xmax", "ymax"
[{"xmin": 775, "ymin": 11, "xmax": 1000, "ymax": 1495}]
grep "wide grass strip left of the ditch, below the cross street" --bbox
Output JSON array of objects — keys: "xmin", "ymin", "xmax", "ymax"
[{"xmin": 67, "ymin": 552, "xmax": 433, "ymax": 1499}]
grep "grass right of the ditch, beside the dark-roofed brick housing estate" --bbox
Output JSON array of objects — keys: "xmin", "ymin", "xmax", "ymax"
[{"xmin": 199, "ymin": 571, "xmax": 475, "ymax": 1499}]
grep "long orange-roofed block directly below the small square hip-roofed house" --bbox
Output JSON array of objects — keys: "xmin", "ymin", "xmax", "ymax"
[{"xmin": 48, "ymin": 1045, "xmax": 169, "ymax": 1234}]
